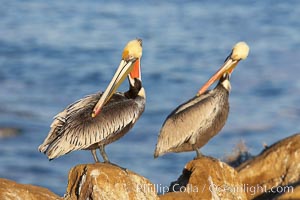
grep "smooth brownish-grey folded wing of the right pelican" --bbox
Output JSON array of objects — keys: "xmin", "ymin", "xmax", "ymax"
[{"xmin": 154, "ymin": 91, "xmax": 227, "ymax": 157}]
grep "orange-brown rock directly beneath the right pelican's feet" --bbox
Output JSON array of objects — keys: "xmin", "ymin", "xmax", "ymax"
[{"xmin": 160, "ymin": 156, "xmax": 247, "ymax": 200}]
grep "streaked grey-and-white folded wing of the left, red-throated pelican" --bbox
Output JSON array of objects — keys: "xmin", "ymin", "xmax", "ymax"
[{"xmin": 41, "ymin": 93, "xmax": 143, "ymax": 159}]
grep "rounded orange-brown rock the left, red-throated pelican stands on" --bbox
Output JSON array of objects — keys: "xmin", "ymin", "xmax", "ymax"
[{"xmin": 65, "ymin": 163, "xmax": 158, "ymax": 200}]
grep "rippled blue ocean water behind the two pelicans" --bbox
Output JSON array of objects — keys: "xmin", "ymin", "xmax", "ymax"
[{"xmin": 0, "ymin": 0, "xmax": 300, "ymax": 195}]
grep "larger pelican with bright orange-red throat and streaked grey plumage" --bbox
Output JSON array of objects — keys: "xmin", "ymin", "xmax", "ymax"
[{"xmin": 39, "ymin": 39, "xmax": 146, "ymax": 162}]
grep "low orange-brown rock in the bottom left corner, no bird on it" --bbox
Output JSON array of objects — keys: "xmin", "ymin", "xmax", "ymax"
[{"xmin": 0, "ymin": 178, "xmax": 62, "ymax": 200}]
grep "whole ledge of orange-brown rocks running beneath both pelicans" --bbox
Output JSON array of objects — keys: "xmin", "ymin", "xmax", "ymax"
[{"xmin": 0, "ymin": 134, "xmax": 300, "ymax": 200}]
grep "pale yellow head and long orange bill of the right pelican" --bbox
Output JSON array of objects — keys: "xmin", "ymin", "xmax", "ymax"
[{"xmin": 197, "ymin": 42, "xmax": 249, "ymax": 96}]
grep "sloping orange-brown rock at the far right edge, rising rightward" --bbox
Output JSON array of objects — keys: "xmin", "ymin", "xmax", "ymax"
[{"xmin": 236, "ymin": 134, "xmax": 300, "ymax": 199}]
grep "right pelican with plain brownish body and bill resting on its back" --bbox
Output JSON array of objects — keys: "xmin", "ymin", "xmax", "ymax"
[{"xmin": 154, "ymin": 42, "xmax": 249, "ymax": 158}]
